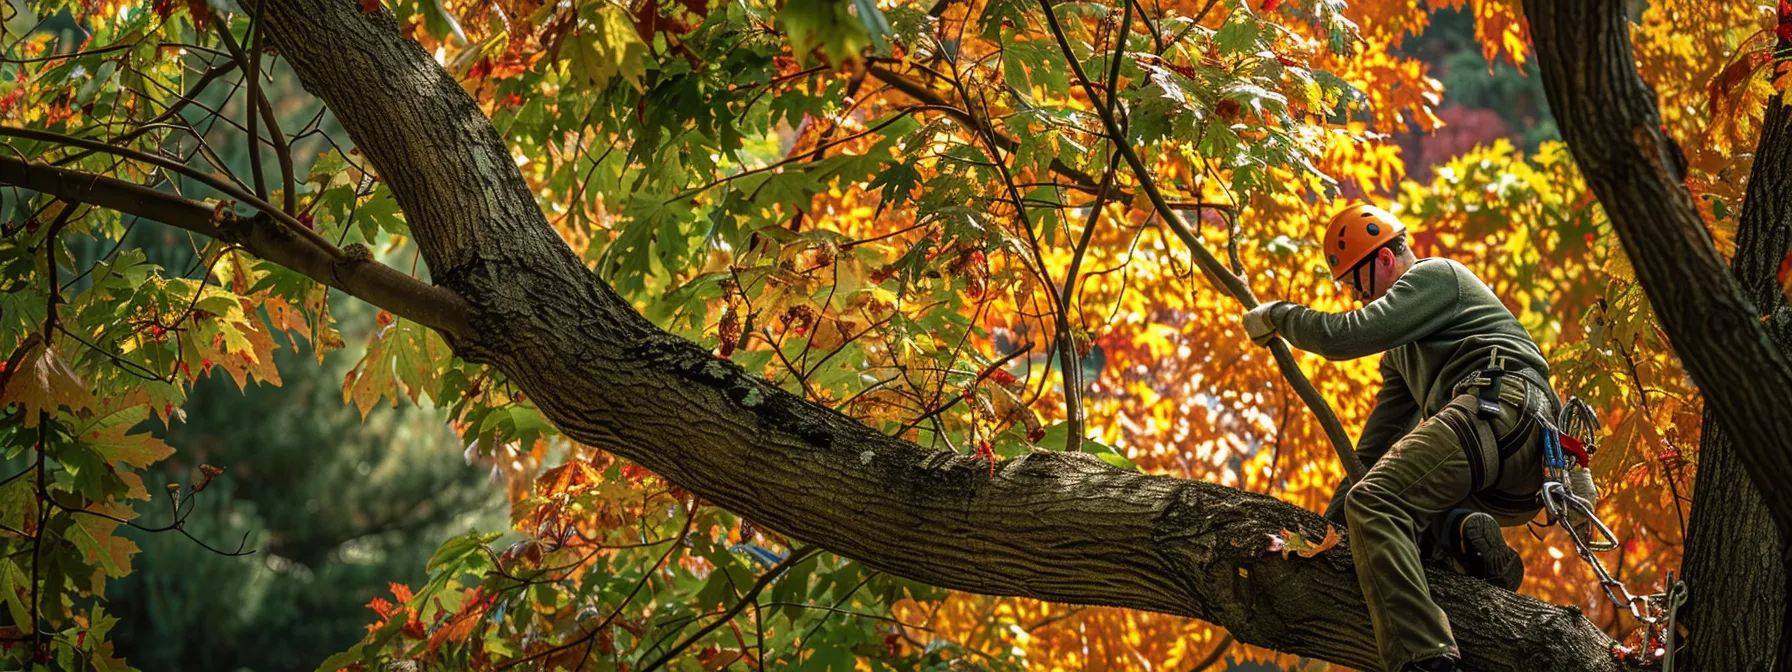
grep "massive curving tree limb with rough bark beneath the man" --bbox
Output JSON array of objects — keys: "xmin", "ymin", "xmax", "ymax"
[{"xmin": 192, "ymin": 0, "xmax": 1641, "ymax": 670}]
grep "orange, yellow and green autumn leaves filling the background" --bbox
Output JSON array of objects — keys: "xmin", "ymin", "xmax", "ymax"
[{"xmin": 0, "ymin": 0, "xmax": 1770, "ymax": 670}]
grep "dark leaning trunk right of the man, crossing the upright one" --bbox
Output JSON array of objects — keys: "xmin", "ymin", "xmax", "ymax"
[{"xmin": 1525, "ymin": 0, "xmax": 1792, "ymax": 532}]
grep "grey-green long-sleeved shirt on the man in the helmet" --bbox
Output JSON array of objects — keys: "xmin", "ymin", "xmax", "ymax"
[{"xmin": 1269, "ymin": 258, "xmax": 1550, "ymax": 442}]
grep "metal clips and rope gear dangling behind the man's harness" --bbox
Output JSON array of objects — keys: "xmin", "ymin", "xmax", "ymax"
[{"xmin": 1543, "ymin": 396, "xmax": 1686, "ymax": 672}]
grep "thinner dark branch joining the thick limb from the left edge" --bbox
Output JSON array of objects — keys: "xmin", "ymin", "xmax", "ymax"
[{"xmin": 0, "ymin": 154, "xmax": 471, "ymax": 337}]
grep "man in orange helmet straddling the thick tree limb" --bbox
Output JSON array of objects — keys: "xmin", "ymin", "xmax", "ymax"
[{"xmin": 1244, "ymin": 204, "xmax": 1557, "ymax": 672}]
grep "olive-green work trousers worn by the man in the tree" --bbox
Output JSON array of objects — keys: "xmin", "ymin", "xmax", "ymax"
[{"xmin": 1344, "ymin": 378, "xmax": 1543, "ymax": 672}]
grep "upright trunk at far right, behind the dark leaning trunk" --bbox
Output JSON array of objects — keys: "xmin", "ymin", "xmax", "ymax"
[{"xmin": 1681, "ymin": 97, "xmax": 1792, "ymax": 672}]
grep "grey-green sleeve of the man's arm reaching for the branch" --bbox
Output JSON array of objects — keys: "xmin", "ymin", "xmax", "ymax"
[{"xmin": 1269, "ymin": 260, "xmax": 1462, "ymax": 360}]
